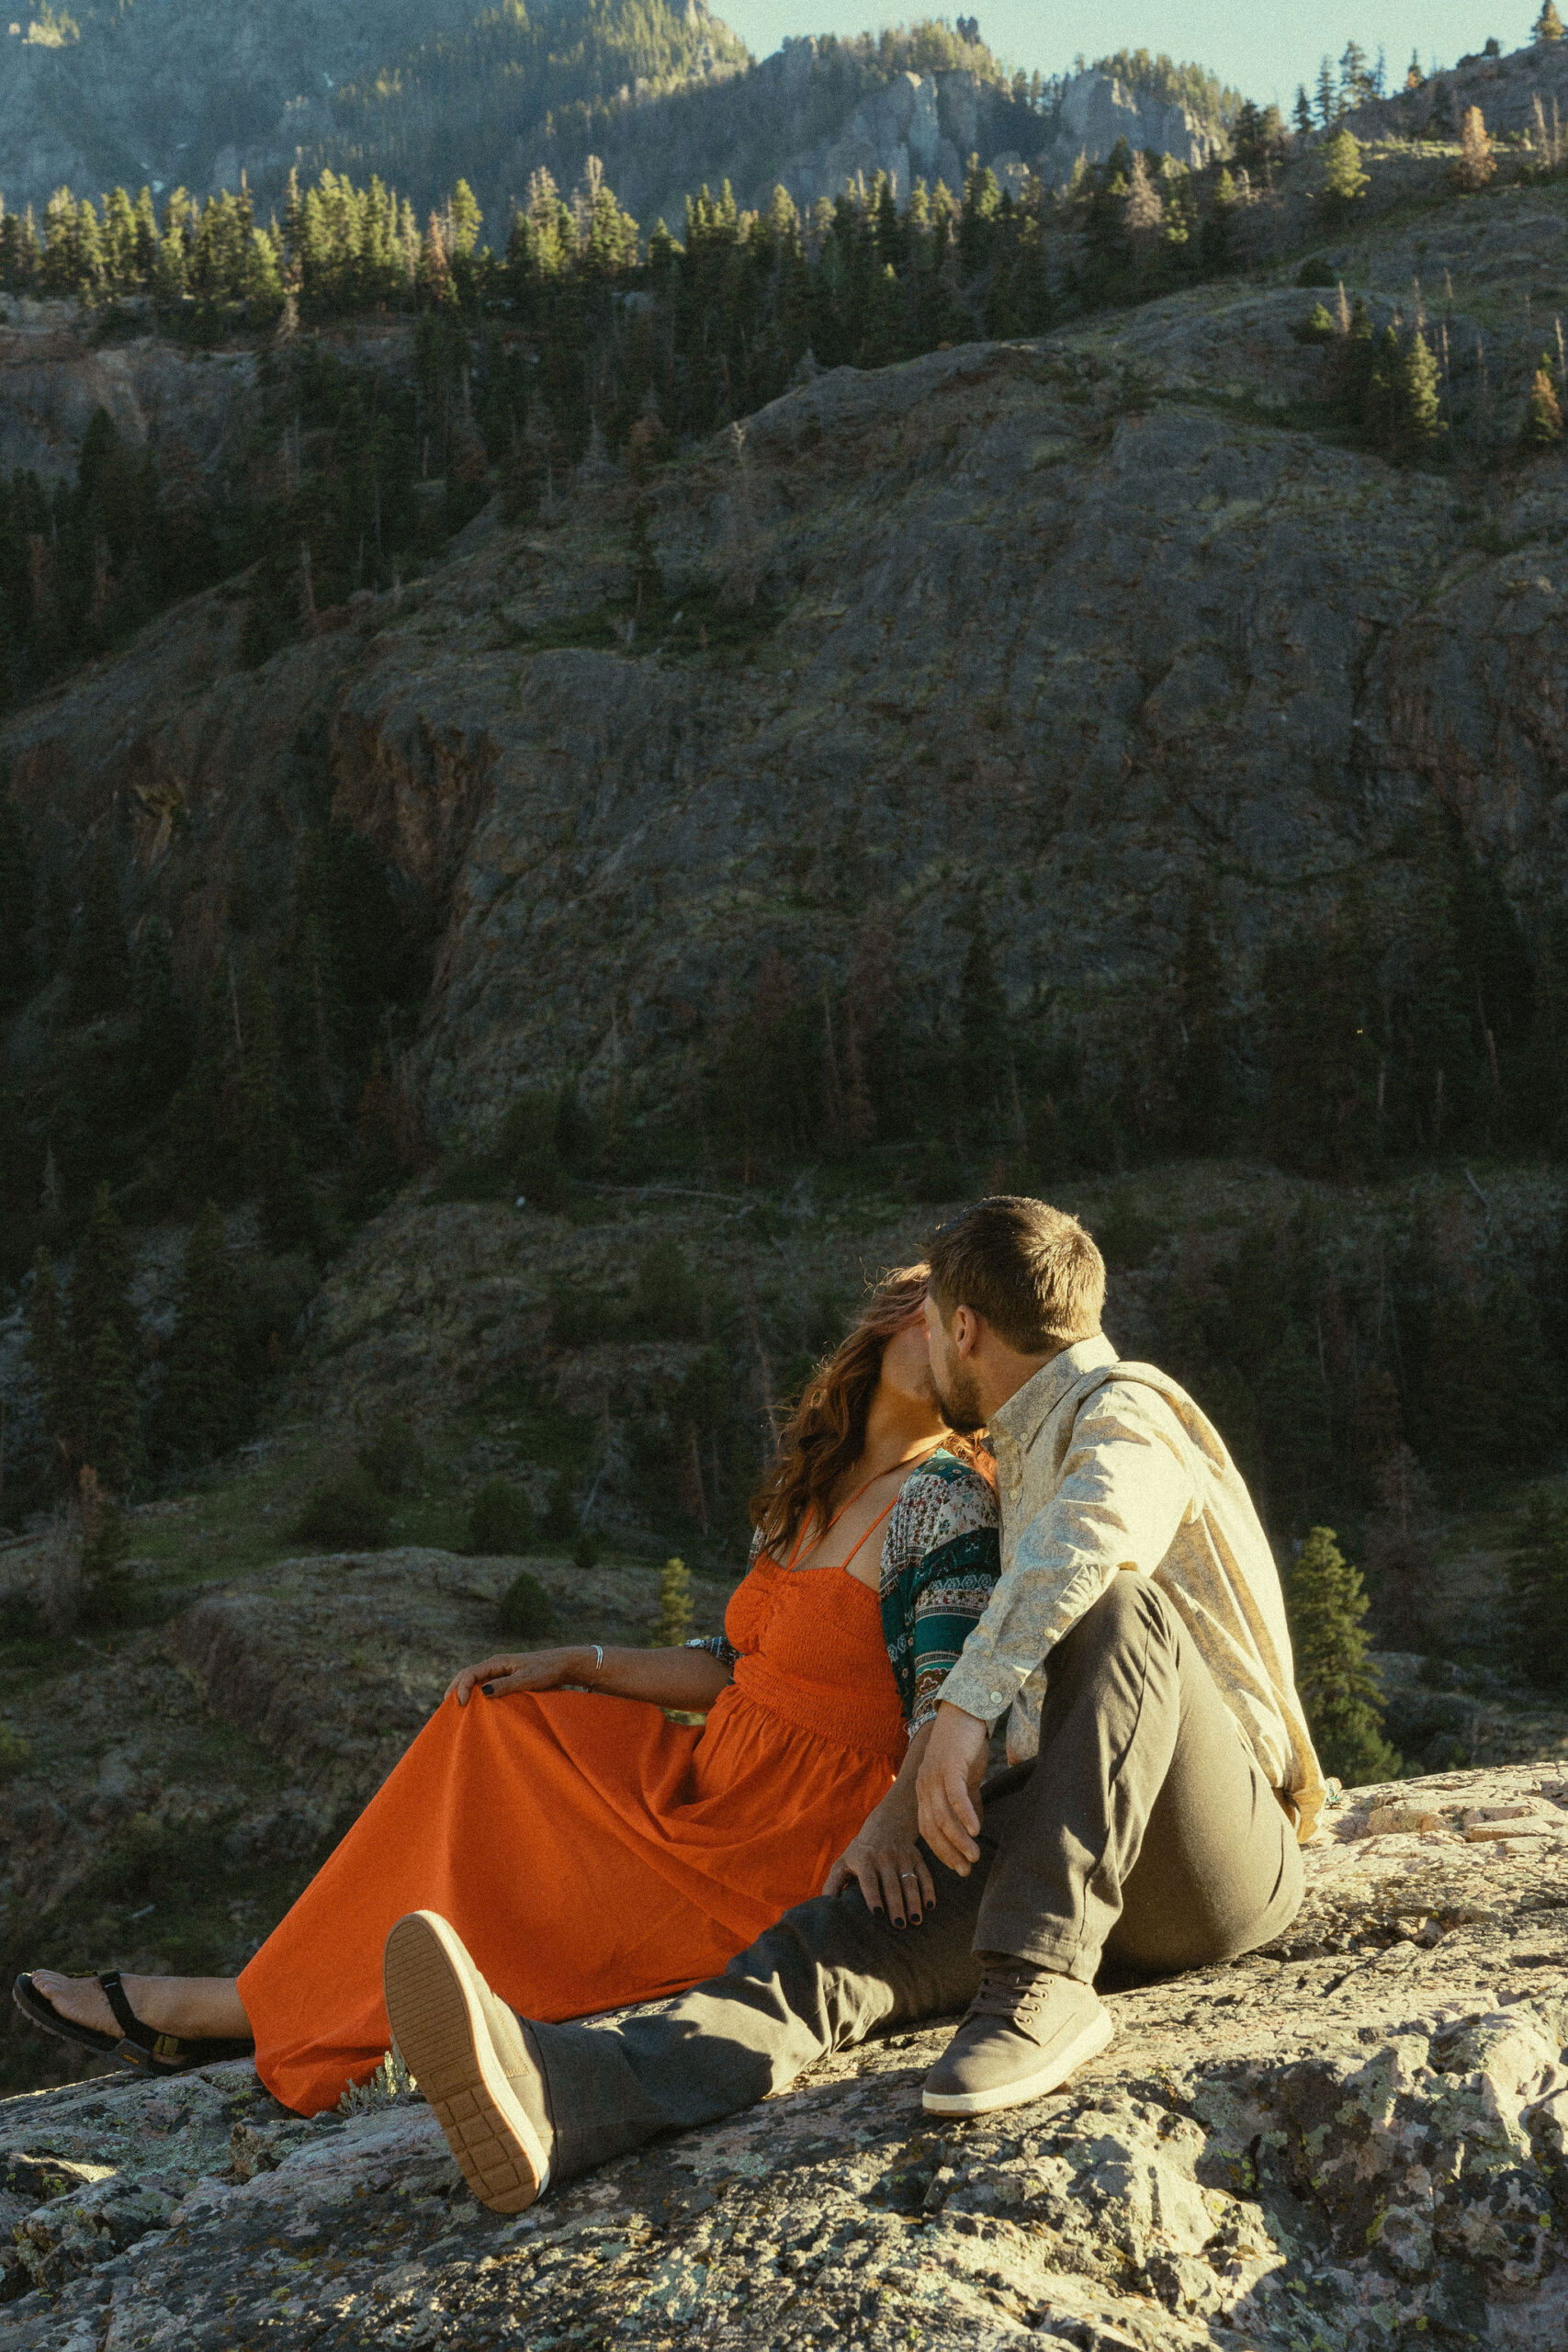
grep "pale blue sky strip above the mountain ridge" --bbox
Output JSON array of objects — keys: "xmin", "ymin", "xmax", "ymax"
[{"xmin": 710, "ymin": 0, "xmax": 1540, "ymax": 106}]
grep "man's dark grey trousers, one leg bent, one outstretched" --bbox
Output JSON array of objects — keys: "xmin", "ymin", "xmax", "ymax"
[{"xmin": 529, "ymin": 1574, "xmax": 1303, "ymax": 2180}]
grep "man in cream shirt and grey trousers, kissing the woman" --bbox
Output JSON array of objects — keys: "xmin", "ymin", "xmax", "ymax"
[{"xmin": 386, "ymin": 1197, "xmax": 1324, "ymax": 2213}]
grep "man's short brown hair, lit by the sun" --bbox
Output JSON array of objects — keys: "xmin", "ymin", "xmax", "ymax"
[{"xmin": 926, "ymin": 1193, "xmax": 1105, "ymax": 1355}]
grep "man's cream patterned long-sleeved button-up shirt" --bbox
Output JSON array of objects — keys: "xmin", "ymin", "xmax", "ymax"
[{"xmin": 941, "ymin": 1339, "xmax": 1324, "ymax": 1841}]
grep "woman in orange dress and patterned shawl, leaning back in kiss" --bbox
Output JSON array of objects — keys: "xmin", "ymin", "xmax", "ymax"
[{"xmin": 17, "ymin": 1265, "xmax": 999, "ymax": 2114}]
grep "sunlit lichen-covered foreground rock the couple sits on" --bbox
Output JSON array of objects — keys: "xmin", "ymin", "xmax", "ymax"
[{"xmin": 0, "ymin": 1769, "xmax": 1568, "ymax": 2352}]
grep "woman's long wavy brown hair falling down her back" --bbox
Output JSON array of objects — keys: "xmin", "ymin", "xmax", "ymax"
[{"xmin": 752, "ymin": 1261, "xmax": 976, "ymax": 1553}]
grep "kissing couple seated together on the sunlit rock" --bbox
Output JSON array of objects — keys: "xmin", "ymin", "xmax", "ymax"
[{"xmin": 17, "ymin": 1197, "xmax": 1324, "ymax": 2213}]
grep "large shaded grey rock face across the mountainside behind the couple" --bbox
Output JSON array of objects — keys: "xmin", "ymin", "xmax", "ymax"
[{"xmin": 0, "ymin": 156, "xmax": 1568, "ymax": 1126}]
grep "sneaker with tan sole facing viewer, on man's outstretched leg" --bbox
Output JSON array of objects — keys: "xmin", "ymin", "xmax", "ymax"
[{"xmin": 381, "ymin": 1912, "xmax": 555, "ymax": 2213}]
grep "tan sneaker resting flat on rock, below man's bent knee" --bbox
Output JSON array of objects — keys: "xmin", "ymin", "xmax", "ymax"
[{"xmin": 921, "ymin": 1959, "xmax": 1117, "ymax": 2114}]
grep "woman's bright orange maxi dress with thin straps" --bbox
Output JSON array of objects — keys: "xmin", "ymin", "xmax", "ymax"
[{"xmin": 240, "ymin": 1553, "xmax": 905, "ymax": 2114}]
